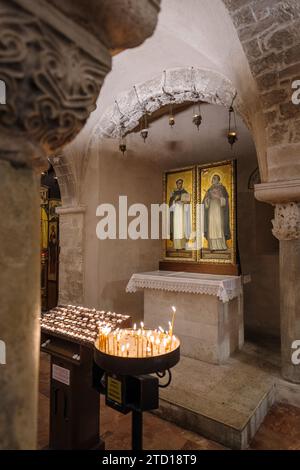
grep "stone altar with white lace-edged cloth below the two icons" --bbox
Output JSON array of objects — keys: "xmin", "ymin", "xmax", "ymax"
[{"xmin": 126, "ymin": 271, "xmax": 244, "ymax": 364}]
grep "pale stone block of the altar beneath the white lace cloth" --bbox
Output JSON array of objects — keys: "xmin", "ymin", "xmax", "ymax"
[{"xmin": 144, "ymin": 289, "xmax": 244, "ymax": 364}]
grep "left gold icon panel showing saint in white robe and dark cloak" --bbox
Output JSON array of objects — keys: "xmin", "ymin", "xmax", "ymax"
[{"xmin": 163, "ymin": 166, "xmax": 197, "ymax": 261}]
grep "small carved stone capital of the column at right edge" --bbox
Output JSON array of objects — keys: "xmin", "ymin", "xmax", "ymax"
[{"xmin": 272, "ymin": 202, "xmax": 300, "ymax": 240}]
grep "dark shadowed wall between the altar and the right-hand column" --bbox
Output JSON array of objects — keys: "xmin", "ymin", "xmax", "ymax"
[{"xmin": 238, "ymin": 191, "xmax": 280, "ymax": 338}]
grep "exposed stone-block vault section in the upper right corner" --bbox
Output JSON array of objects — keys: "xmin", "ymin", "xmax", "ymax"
[{"xmin": 223, "ymin": 0, "xmax": 300, "ymax": 146}]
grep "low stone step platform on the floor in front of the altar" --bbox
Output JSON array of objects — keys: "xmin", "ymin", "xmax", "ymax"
[{"xmin": 156, "ymin": 352, "xmax": 275, "ymax": 449}]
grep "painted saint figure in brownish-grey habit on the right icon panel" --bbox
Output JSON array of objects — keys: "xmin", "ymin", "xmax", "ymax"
[{"xmin": 202, "ymin": 175, "xmax": 231, "ymax": 251}]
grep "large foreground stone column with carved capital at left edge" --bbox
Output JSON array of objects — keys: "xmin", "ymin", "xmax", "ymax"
[{"xmin": 0, "ymin": 0, "xmax": 159, "ymax": 449}]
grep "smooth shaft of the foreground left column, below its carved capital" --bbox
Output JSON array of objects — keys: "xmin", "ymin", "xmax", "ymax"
[{"xmin": 0, "ymin": 159, "xmax": 40, "ymax": 449}]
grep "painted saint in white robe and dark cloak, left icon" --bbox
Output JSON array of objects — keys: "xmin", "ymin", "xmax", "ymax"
[{"xmin": 169, "ymin": 178, "xmax": 191, "ymax": 250}]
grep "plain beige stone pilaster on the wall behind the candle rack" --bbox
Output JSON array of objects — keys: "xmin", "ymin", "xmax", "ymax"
[{"xmin": 56, "ymin": 206, "xmax": 85, "ymax": 305}]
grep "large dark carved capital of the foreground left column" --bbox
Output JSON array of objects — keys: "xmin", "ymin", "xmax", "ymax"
[{"xmin": 0, "ymin": 0, "xmax": 110, "ymax": 165}]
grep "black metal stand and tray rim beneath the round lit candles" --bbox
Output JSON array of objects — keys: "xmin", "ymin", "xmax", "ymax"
[{"xmin": 93, "ymin": 345, "xmax": 180, "ymax": 451}]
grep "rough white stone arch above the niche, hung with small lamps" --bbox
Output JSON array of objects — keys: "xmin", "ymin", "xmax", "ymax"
[{"xmin": 88, "ymin": 67, "xmax": 251, "ymax": 140}]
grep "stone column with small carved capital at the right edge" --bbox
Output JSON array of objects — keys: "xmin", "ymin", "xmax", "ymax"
[{"xmin": 273, "ymin": 202, "xmax": 300, "ymax": 383}]
